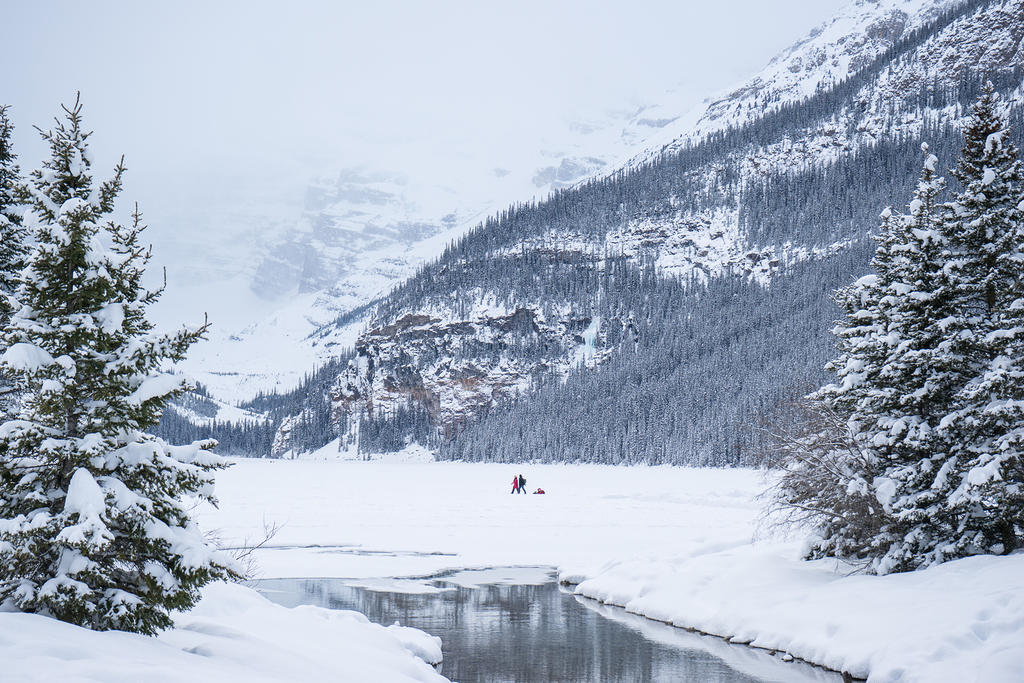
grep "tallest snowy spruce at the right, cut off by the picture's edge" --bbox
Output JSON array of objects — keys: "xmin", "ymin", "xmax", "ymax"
[{"xmin": 933, "ymin": 84, "xmax": 1024, "ymax": 558}]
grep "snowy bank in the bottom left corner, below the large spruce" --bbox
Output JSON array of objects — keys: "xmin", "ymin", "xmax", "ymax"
[{"xmin": 0, "ymin": 584, "xmax": 447, "ymax": 683}]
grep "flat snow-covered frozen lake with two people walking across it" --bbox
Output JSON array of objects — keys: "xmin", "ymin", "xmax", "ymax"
[{"xmin": 201, "ymin": 459, "xmax": 762, "ymax": 579}]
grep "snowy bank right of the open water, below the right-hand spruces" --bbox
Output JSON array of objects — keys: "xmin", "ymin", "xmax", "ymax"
[{"xmin": 559, "ymin": 544, "xmax": 1024, "ymax": 683}]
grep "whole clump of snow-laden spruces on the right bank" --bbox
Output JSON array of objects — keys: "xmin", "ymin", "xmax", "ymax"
[{"xmin": 778, "ymin": 86, "xmax": 1024, "ymax": 573}]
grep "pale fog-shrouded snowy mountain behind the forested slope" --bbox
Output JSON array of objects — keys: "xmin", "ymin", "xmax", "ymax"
[{"xmin": 180, "ymin": 103, "xmax": 700, "ymax": 400}]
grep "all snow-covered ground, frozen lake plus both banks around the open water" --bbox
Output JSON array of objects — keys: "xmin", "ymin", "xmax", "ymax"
[{"xmin": 0, "ymin": 462, "xmax": 1024, "ymax": 683}]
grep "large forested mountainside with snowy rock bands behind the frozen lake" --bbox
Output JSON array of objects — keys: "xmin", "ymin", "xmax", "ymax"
[{"xmin": 169, "ymin": 0, "xmax": 1024, "ymax": 464}]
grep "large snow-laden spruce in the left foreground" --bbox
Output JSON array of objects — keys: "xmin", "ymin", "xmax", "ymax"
[{"xmin": 0, "ymin": 98, "xmax": 236, "ymax": 634}]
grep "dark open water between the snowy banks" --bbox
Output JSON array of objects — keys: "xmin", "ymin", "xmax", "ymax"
[{"xmin": 256, "ymin": 571, "xmax": 842, "ymax": 683}]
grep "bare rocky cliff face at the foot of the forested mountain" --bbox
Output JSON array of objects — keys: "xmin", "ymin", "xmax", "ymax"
[{"xmin": 332, "ymin": 305, "xmax": 598, "ymax": 438}]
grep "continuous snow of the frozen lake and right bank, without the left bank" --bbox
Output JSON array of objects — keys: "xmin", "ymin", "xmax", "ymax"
[{"xmin": 193, "ymin": 461, "xmax": 1024, "ymax": 683}]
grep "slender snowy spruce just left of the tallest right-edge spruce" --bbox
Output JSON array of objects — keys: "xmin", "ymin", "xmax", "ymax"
[{"xmin": 858, "ymin": 145, "xmax": 959, "ymax": 573}]
